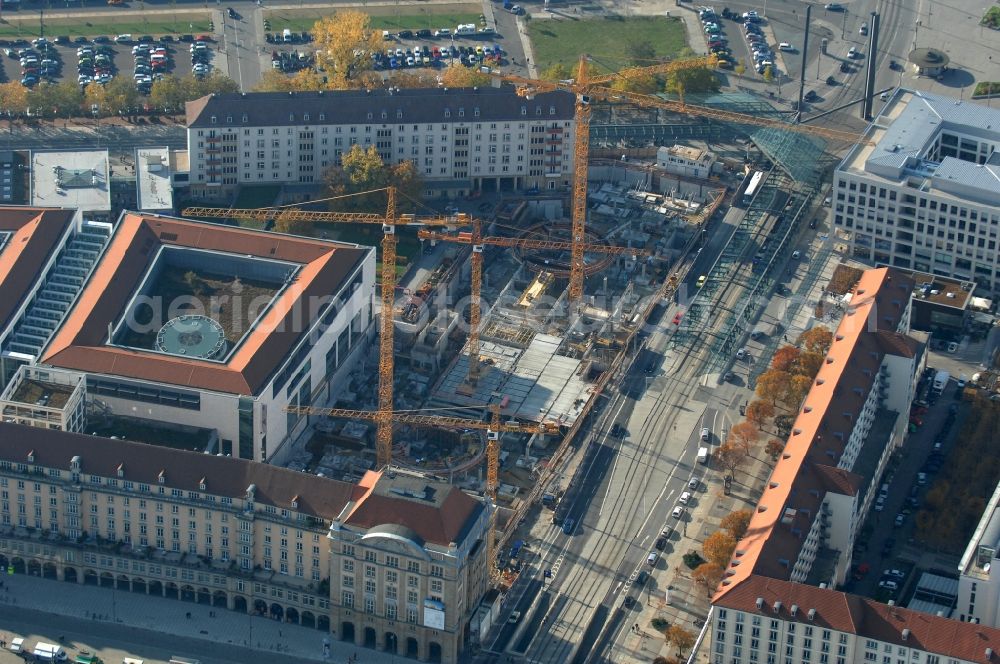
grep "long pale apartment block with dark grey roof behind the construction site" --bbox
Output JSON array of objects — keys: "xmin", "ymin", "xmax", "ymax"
[{"xmin": 187, "ymin": 86, "xmax": 574, "ymax": 199}]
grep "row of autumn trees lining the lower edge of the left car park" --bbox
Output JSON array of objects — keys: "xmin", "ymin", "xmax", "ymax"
[{"xmin": 0, "ymin": 72, "xmax": 239, "ymax": 118}]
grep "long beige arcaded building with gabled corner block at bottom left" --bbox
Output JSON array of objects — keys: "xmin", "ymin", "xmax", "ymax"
[{"xmin": 0, "ymin": 423, "xmax": 492, "ymax": 662}]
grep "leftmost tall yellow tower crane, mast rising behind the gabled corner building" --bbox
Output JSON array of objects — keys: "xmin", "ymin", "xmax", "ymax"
[{"xmin": 183, "ymin": 187, "xmax": 469, "ymax": 468}]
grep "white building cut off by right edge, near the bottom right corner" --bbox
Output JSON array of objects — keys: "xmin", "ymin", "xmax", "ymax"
[{"xmin": 955, "ymin": 484, "xmax": 1000, "ymax": 627}]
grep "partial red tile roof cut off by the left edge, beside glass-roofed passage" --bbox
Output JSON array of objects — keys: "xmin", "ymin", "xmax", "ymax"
[{"xmin": 0, "ymin": 207, "xmax": 76, "ymax": 329}]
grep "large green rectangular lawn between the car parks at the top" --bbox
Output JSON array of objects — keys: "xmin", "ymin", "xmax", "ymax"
[{"xmin": 528, "ymin": 16, "xmax": 687, "ymax": 72}]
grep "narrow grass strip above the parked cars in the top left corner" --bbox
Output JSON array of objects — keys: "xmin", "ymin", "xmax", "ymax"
[{"xmin": 0, "ymin": 12, "xmax": 209, "ymax": 39}]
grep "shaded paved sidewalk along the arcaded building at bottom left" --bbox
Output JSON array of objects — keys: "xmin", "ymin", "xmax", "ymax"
[{"xmin": 0, "ymin": 575, "xmax": 398, "ymax": 664}]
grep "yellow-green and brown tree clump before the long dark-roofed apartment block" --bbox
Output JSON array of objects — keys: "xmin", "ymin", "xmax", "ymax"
[{"xmin": 323, "ymin": 144, "xmax": 423, "ymax": 211}]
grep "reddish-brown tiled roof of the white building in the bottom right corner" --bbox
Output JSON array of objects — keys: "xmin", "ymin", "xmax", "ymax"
[{"xmin": 715, "ymin": 574, "xmax": 1000, "ymax": 662}]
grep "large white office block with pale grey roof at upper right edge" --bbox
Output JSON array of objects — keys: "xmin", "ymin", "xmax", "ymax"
[{"xmin": 832, "ymin": 90, "xmax": 1000, "ymax": 294}]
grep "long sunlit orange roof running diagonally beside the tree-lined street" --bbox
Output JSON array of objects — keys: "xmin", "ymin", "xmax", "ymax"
[{"xmin": 716, "ymin": 268, "xmax": 913, "ymax": 599}]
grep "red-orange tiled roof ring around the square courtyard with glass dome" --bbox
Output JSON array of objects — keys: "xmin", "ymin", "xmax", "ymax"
[{"xmin": 41, "ymin": 214, "xmax": 371, "ymax": 395}]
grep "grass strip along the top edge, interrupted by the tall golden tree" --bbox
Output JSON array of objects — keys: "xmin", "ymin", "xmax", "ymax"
[{"xmin": 265, "ymin": 4, "xmax": 481, "ymax": 32}]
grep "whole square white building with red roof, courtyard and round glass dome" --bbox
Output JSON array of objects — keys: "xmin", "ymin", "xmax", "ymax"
[{"xmin": 28, "ymin": 214, "xmax": 375, "ymax": 463}]
